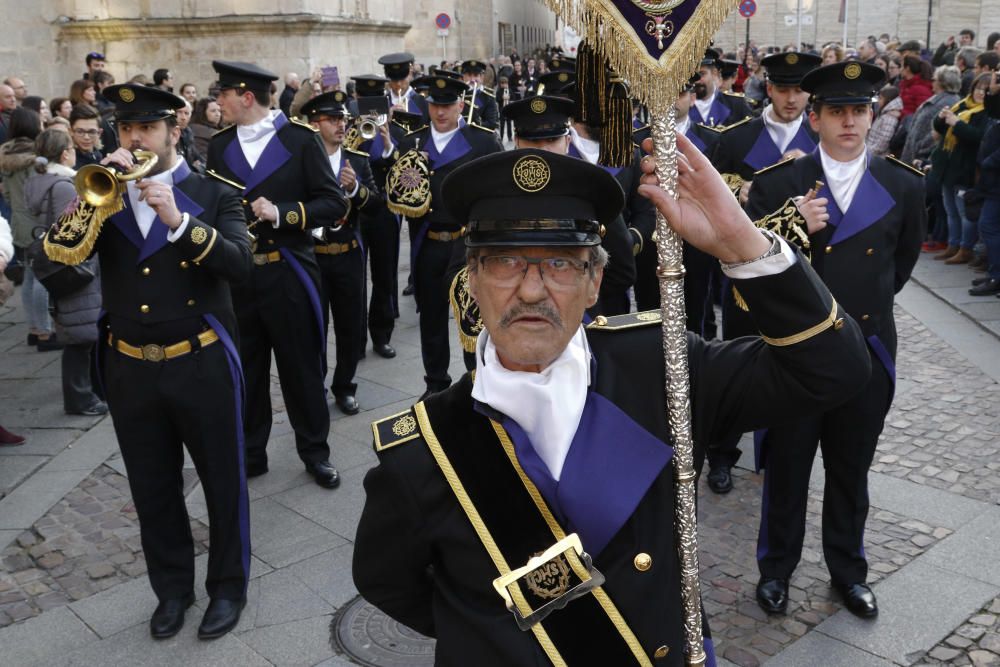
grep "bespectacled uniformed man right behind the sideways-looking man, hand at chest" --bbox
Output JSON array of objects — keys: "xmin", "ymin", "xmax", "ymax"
[{"xmin": 302, "ymin": 90, "xmax": 381, "ymax": 415}]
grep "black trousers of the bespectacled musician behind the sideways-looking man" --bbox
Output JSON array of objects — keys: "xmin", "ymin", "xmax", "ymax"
[{"xmin": 316, "ymin": 248, "xmax": 365, "ymax": 396}]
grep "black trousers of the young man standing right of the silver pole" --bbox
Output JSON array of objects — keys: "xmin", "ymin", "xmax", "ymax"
[{"xmin": 757, "ymin": 354, "xmax": 893, "ymax": 585}]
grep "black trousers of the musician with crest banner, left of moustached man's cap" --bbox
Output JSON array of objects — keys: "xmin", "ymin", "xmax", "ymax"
[{"xmin": 410, "ymin": 228, "xmax": 462, "ymax": 391}]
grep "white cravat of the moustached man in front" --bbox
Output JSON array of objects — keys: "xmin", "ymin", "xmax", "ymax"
[{"xmin": 472, "ymin": 325, "xmax": 590, "ymax": 481}]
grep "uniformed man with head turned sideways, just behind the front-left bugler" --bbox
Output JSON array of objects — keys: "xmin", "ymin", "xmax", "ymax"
[{"xmin": 207, "ymin": 60, "xmax": 350, "ymax": 489}]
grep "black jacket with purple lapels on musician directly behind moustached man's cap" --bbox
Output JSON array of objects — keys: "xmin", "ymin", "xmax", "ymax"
[{"xmin": 398, "ymin": 124, "xmax": 503, "ymax": 231}]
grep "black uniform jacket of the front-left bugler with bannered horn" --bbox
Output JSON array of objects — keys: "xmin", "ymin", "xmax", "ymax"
[{"xmin": 95, "ymin": 167, "xmax": 251, "ymax": 344}]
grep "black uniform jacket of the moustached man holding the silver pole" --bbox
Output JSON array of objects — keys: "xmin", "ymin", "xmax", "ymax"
[{"xmin": 354, "ymin": 258, "xmax": 871, "ymax": 667}]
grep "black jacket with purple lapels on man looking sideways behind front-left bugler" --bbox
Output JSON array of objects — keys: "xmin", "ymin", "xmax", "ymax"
[{"xmin": 208, "ymin": 115, "xmax": 350, "ymax": 281}]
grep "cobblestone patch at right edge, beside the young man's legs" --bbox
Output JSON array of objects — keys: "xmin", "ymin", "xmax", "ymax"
[{"xmin": 872, "ymin": 308, "xmax": 1000, "ymax": 503}]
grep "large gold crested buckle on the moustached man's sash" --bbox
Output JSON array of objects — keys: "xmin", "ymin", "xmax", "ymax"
[{"xmin": 493, "ymin": 533, "xmax": 604, "ymax": 630}]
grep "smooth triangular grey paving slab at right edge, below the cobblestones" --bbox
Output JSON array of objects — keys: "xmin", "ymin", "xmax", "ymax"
[{"xmin": 925, "ymin": 507, "xmax": 1000, "ymax": 586}]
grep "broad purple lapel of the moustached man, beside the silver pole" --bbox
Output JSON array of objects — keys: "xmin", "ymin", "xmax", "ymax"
[{"xmin": 556, "ymin": 391, "xmax": 673, "ymax": 556}]
